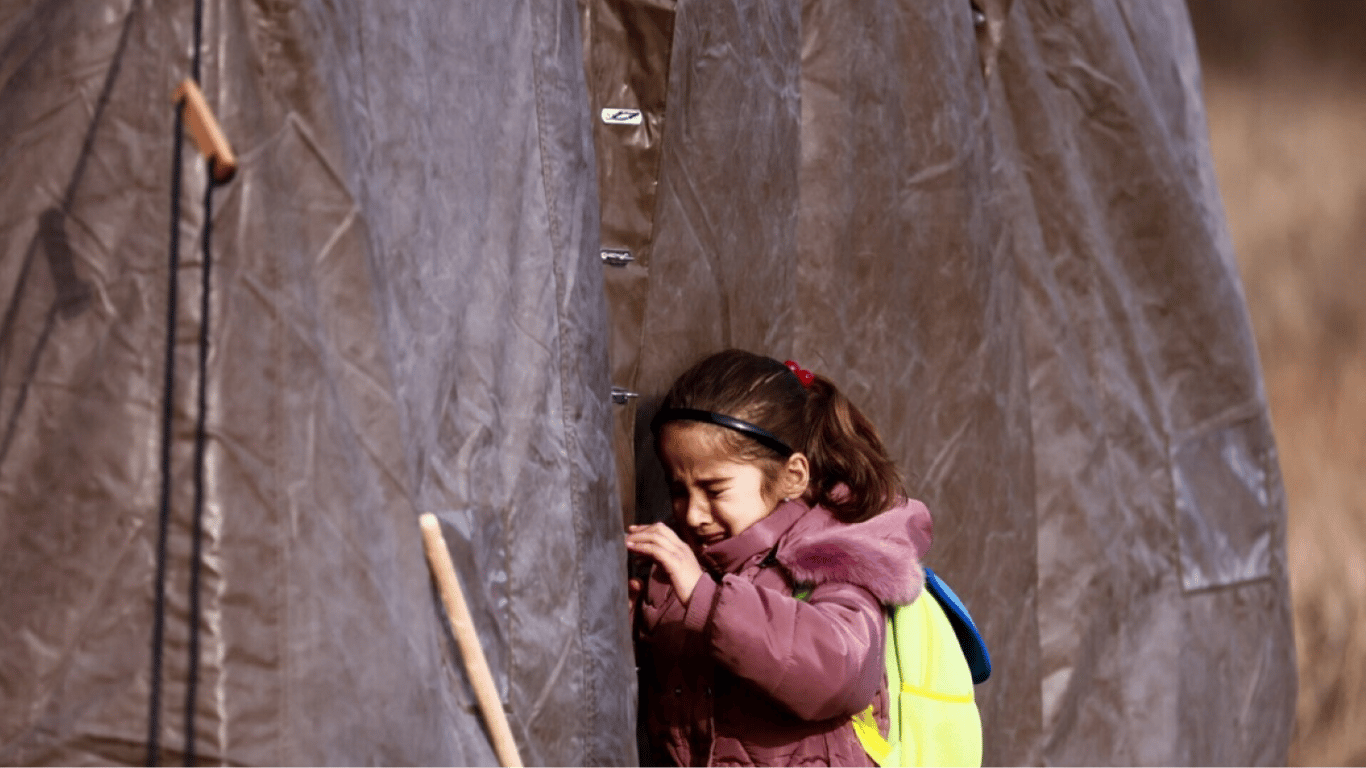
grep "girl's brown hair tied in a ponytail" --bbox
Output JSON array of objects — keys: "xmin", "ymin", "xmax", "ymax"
[{"xmin": 660, "ymin": 350, "xmax": 906, "ymax": 522}]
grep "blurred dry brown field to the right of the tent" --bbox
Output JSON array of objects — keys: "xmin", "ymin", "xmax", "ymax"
[{"xmin": 1187, "ymin": 0, "xmax": 1366, "ymax": 765}]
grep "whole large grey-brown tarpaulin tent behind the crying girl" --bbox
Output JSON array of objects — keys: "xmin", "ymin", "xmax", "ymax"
[{"xmin": 0, "ymin": 0, "xmax": 1295, "ymax": 765}]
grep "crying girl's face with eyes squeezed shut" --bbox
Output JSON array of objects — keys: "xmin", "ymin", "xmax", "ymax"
[{"xmin": 658, "ymin": 421, "xmax": 786, "ymax": 548}]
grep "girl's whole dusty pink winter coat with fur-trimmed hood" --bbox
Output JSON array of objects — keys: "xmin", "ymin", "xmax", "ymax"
[{"xmin": 635, "ymin": 491, "xmax": 930, "ymax": 767}]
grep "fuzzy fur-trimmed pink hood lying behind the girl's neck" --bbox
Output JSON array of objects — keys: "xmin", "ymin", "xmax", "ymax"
[{"xmin": 776, "ymin": 500, "xmax": 932, "ymax": 605}]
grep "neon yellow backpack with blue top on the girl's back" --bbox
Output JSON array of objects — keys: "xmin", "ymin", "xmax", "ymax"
[{"xmin": 852, "ymin": 568, "xmax": 992, "ymax": 768}]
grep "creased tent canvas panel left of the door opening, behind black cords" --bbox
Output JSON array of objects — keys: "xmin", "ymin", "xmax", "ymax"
[{"xmin": 0, "ymin": 0, "xmax": 635, "ymax": 765}]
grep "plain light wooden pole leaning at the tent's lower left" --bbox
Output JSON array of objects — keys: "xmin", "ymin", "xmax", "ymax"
[{"xmin": 418, "ymin": 512, "xmax": 522, "ymax": 768}]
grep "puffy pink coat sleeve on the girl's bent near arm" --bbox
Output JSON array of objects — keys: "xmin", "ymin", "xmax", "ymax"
[{"xmin": 684, "ymin": 575, "xmax": 887, "ymax": 720}]
